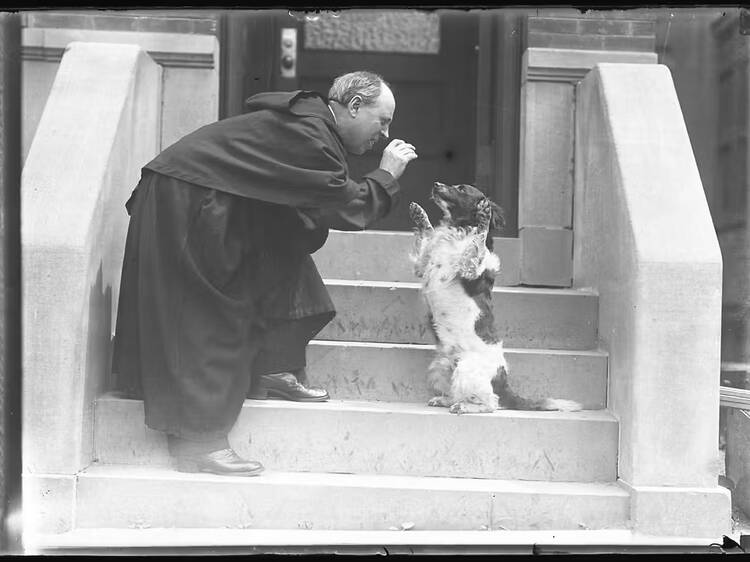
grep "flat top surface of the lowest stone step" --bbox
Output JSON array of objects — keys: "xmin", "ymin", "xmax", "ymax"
[{"xmin": 78, "ymin": 463, "xmax": 628, "ymax": 492}]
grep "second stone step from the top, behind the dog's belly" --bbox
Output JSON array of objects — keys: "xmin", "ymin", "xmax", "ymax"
[{"xmin": 317, "ymin": 279, "xmax": 599, "ymax": 350}]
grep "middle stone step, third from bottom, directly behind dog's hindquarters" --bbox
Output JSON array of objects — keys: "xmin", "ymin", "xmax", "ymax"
[{"xmin": 307, "ymin": 340, "xmax": 607, "ymax": 410}]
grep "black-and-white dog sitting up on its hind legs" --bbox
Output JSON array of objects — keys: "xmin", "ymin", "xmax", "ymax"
[{"xmin": 409, "ymin": 182, "xmax": 581, "ymax": 414}]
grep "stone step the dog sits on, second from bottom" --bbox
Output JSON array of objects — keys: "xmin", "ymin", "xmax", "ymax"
[{"xmin": 95, "ymin": 397, "xmax": 618, "ymax": 482}]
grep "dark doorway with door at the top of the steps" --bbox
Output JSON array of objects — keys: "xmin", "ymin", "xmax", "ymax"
[{"xmin": 221, "ymin": 10, "xmax": 520, "ymax": 232}]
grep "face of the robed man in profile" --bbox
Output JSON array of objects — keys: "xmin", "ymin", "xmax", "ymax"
[{"xmin": 340, "ymin": 85, "xmax": 396, "ymax": 154}]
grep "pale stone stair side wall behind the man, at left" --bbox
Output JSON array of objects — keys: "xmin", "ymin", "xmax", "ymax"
[{"xmin": 21, "ymin": 43, "xmax": 161, "ymax": 474}]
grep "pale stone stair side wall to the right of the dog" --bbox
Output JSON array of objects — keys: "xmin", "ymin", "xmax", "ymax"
[{"xmin": 574, "ymin": 64, "xmax": 727, "ymax": 532}]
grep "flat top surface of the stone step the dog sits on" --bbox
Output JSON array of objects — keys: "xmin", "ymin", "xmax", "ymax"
[{"xmin": 99, "ymin": 395, "xmax": 617, "ymax": 423}]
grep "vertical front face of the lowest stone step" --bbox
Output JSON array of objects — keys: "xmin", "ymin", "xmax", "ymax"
[{"xmin": 76, "ymin": 477, "xmax": 629, "ymax": 530}]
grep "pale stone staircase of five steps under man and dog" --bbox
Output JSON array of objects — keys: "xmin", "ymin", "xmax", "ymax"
[{"xmin": 82, "ymin": 232, "xmax": 630, "ymax": 531}]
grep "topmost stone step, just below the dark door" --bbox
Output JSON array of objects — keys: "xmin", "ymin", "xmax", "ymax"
[{"xmin": 313, "ymin": 230, "xmax": 521, "ymax": 286}]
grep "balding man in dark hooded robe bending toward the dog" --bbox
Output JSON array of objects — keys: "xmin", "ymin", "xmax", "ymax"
[{"xmin": 113, "ymin": 72, "xmax": 417, "ymax": 476}]
